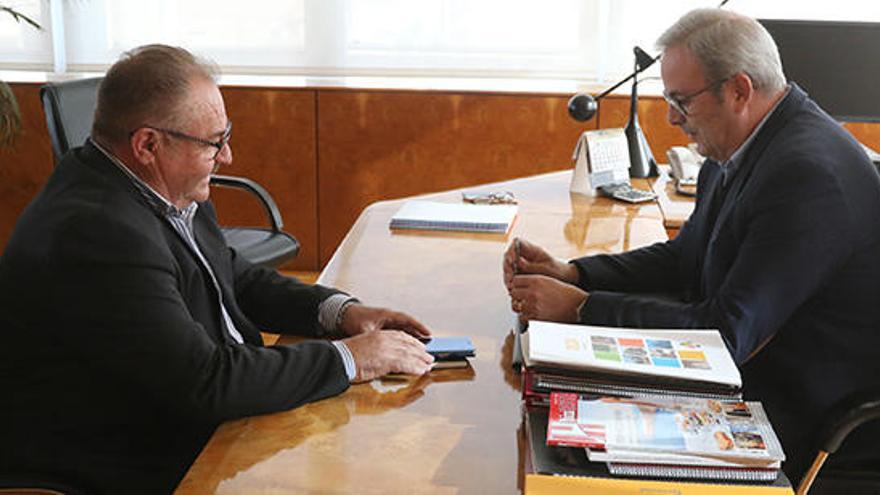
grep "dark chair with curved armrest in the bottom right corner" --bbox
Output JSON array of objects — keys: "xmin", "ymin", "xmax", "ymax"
[{"xmin": 797, "ymin": 389, "xmax": 880, "ymax": 495}]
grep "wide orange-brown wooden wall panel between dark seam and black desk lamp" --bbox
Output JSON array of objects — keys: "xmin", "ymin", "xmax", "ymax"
[{"xmin": 318, "ymin": 90, "xmax": 595, "ymax": 263}]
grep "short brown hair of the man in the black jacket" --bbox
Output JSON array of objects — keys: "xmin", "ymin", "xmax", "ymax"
[{"xmin": 92, "ymin": 45, "xmax": 218, "ymax": 143}]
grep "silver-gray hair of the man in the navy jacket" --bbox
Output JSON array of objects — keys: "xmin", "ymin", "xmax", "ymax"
[{"xmin": 657, "ymin": 9, "xmax": 785, "ymax": 93}]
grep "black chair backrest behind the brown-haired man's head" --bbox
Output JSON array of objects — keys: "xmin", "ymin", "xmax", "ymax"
[{"xmin": 40, "ymin": 77, "xmax": 103, "ymax": 163}]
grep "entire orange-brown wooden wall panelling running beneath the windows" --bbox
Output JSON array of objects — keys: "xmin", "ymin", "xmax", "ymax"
[{"xmin": 0, "ymin": 83, "xmax": 880, "ymax": 270}]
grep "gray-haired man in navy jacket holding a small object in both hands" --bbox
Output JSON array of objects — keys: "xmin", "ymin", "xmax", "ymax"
[{"xmin": 504, "ymin": 9, "xmax": 880, "ymax": 481}]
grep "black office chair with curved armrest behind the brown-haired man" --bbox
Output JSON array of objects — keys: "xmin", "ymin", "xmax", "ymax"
[{"xmin": 40, "ymin": 78, "xmax": 299, "ymax": 268}]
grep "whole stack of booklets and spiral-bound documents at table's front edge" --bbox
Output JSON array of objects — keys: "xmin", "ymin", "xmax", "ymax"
[{"xmin": 518, "ymin": 321, "xmax": 787, "ymax": 493}]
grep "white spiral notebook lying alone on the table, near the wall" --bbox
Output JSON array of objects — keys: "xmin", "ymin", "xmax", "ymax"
[{"xmin": 391, "ymin": 200, "xmax": 517, "ymax": 234}]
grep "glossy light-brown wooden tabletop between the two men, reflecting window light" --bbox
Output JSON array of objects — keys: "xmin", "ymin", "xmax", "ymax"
[{"xmin": 178, "ymin": 171, "xmax": 666, "ymax": 494}]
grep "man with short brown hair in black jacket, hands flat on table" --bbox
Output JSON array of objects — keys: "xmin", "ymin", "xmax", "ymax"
[{"xmin": 0, "ymin": 45, "xmax": 433, "ymax": 493}]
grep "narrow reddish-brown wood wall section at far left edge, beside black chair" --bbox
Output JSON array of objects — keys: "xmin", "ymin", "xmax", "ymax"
[{"xmin": 0, "ymin": 84, "xmax": 54, "ymax": 250}]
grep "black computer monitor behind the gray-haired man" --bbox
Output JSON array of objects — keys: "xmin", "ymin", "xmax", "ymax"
[{"xmin": 760, "ymin": 19, "xmax": 880, "ymax": 122}]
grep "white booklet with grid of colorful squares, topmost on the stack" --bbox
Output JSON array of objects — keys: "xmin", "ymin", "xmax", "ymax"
[{"xmin": 522, "ymin": 321, "xmax": 742, "ymax": 398}]
